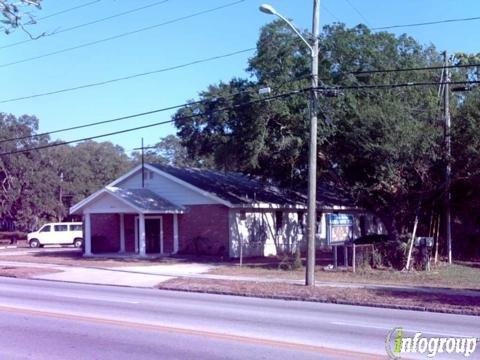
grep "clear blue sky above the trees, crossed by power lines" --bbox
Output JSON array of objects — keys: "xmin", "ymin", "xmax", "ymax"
[{"xmin": 0, "ymin": 0, "xmax": 480, "ymax": 152}]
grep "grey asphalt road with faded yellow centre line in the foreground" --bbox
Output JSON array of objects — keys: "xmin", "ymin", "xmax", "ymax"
[{"xmin": 0, "ymin": 278, "xmax": 480, "ymax": 360}]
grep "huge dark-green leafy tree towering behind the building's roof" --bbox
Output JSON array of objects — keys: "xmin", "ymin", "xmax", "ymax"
[{"xmin": 174, "ymin": 21, "xmax": 444, "ymax": 237}]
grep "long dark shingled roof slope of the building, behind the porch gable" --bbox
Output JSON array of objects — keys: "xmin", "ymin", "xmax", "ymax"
[{"xmin": 148, "ymin": 164, "xmax": 353, "ymax": 208}]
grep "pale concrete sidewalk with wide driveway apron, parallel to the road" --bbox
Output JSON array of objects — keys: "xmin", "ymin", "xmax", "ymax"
[{"xmin": 0, "ymin": 261, "xmax": 480, "ymax": 297}]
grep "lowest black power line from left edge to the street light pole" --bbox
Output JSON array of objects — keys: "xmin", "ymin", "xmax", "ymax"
[{"xmin": 0, "ymin": 88, "xmax": 309, "ymax": 156}]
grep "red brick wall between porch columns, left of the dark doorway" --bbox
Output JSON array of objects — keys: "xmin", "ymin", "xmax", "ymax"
[{"xmin": 91, "ymin": 214, "xmax": 120, "ymax": 254}]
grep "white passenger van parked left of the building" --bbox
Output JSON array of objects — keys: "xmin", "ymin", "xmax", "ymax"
[{"xmin": 27, "ymin": 222, "xmax": 83, "ymax": 248}]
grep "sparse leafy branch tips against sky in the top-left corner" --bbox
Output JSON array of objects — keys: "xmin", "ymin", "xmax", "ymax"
[{"xmin": 0, "ymin": 0, "xmax": 42, "ymax": 36}]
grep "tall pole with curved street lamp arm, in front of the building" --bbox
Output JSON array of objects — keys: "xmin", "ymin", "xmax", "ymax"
[{"xmin": 260, "ymin": 0, "xmax": 320, "ymax": 286}]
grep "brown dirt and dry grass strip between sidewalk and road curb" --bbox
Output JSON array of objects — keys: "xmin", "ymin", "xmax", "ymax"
[{"xmin": 158, "ymin": 279, "xmax": 480, "ymax": 316}]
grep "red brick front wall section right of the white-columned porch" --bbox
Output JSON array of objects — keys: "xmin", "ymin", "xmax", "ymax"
[{"xmin": 178, "ymin": 205, "xmax": 229, "ymax": 255}]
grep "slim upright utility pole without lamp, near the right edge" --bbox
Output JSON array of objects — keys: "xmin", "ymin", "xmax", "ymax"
[{"xmin": 443, "ymin": 51, "xmax": 452, "ymax": 264}]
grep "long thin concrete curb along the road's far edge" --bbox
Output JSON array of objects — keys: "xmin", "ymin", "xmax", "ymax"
[{"xmin": 157, "ymin": 285, "xmax": 480, "ymax": 317}]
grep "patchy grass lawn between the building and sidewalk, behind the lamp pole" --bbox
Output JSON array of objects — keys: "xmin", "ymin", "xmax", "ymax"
[{"xmin": 210, "ymin": 262, "xmax": 480, "ymax": 290}]
